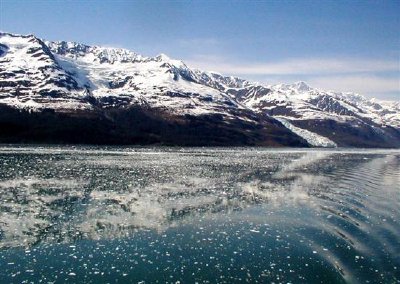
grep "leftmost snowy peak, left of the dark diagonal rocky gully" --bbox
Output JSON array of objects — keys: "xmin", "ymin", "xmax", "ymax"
[{"xmin": 0, "ymin": 33, "xmax": 87, "ymax": 108}]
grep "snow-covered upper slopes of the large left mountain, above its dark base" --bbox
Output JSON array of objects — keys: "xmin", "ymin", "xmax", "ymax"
[{"xmin": 0, "ymin": 33, "xmax": 242, "ymax": 117}]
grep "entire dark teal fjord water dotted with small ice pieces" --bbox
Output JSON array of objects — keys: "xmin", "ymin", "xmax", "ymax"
[{"xmin": 0, "ymin": 146, "xmax": 400, "ymax": 283}]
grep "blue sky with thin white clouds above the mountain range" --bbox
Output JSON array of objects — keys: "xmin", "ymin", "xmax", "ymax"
[{"xmin": 0, "ymin": 0, "xmax": 400, "ymax": 101}]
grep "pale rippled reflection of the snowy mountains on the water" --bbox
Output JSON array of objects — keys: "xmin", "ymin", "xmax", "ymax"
[{"xmin": 0, "ymin": 146, "xmax": 400, "ymax": 248}]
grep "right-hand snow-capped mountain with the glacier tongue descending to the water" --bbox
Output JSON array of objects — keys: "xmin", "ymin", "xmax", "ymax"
[{"xmin": 219, "ymin": 79, "xmax": 400, "ymax": 146}]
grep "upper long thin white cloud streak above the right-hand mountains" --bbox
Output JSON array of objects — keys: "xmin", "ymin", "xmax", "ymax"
[{"xmin": 186, "ymin": 56, "xmax": 400, "ymax": 75}]
